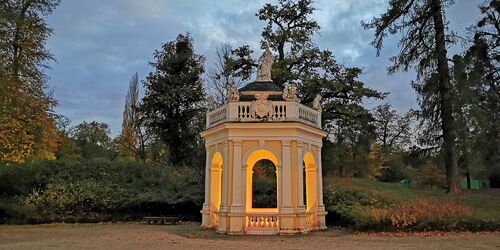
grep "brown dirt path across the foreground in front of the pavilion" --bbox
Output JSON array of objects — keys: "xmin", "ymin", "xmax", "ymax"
[{"xmin": 0, "ymin": 224, "xmax": 500, "ymax": 250}]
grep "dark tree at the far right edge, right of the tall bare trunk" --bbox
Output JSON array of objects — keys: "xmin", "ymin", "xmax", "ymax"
[{"xmin": 460, "ymin": 0, "xmax": 500, "ymax": 187}]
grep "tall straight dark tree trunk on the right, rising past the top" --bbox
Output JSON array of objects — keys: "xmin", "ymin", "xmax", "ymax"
[{"xmin": 431, "ymin": 0, "xmax": 461, "ymax": 194}]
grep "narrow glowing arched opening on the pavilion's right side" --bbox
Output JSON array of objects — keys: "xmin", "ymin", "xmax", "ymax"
[{"xmin": 303, "ymin": 152, "xmax": 318, "ymax": 212}]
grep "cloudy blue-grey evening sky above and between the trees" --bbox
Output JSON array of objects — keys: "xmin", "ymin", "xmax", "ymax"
[{"xmin": 46, "ymin": 0, "xmax": 483, "ymax": 136}]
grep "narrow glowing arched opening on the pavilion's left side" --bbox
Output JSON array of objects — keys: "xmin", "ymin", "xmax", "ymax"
[{"xmin": 210, "ymin": 152, "xmax": 223, "ymax": 225}]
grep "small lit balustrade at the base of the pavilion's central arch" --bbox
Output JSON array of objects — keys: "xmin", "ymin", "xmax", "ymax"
[{"xmin": 245, "ymin": 214, "xmax": 279, "ymax": 234}]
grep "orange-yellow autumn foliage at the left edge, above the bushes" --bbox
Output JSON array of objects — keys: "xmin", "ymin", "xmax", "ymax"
[{"xmin": 0, "ymin": 74, "xmax": 61, "ymax": 163}]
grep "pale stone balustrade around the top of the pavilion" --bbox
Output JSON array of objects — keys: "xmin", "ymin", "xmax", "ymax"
[{"xmin": 206, "ymin": 101, "xmax": 321, "ymax": 128}]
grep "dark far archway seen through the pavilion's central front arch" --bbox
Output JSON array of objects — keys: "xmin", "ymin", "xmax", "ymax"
[{"xmin": 252, "ymin": 159, "xmax": 278, "ymax": 208}]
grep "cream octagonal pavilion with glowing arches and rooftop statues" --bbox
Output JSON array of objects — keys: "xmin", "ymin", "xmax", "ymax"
[{"xmin": 201, "ymin": 50, "xmax": 327, "ymax": 235}]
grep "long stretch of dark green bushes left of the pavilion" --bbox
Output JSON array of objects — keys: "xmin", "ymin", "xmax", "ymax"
[{"xmin": 0, "ymin": 160, "xmax": 204, "ymax": 223}]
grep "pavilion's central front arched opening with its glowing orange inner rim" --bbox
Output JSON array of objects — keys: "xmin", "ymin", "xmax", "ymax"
[{"xmin": 245, "ymin": 149, "xmax": 280, "ymax": 212}]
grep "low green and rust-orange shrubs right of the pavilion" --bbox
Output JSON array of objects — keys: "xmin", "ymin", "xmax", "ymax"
[{"xmin": 324, "ymin": 186, "xmax": 500, "ymax": 231}]
